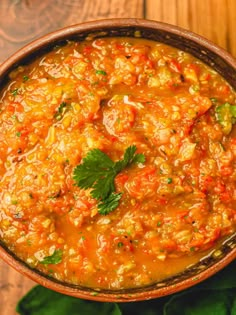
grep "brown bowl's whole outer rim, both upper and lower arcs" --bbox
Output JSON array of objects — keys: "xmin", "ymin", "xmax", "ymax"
[{"xmin": 0, "ymin": 18, "xmax": 236, "ymax": 302}]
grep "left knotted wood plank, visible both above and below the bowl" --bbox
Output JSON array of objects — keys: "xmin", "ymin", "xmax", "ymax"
[{"xmin": 0, "ymin": 0, "xmax": 144, "ymax": 315}]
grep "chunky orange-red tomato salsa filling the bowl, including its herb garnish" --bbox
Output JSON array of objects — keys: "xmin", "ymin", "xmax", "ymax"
[{"xmin": 0, "ymin": 37, "xmax": 236, "ymax": 290}]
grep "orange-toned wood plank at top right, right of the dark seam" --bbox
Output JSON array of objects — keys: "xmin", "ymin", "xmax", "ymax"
[{"xmin": 145, "ymin": 0, "xmax": 236, "ymax": 57}]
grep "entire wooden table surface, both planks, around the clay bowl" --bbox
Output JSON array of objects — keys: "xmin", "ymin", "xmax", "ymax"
[{"xmin": 0, "ymin": 0, "xmax": 236, "ymax": 315}]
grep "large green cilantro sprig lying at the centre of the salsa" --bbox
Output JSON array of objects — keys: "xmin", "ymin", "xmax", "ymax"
[{"xmin": 73, "ymin": 145, "xmax": 145, "ymax": 215}]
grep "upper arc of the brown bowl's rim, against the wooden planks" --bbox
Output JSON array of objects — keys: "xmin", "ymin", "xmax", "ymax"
[{"xmin": 0, "ymin": 18, "xmax": 236, "ymax": 73}]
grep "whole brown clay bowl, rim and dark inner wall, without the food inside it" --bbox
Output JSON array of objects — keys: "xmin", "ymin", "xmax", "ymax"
[{"xmin": 0, "ymin": 19, "xmax": 236, "ymax": 302}]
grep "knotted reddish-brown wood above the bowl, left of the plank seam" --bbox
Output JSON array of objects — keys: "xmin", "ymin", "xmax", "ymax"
[{"xmin": 0, "ymin": 0, "xmax": 144, "ymax": 62}]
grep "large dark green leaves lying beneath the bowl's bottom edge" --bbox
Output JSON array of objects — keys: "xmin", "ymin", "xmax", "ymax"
[{"xmin": 17, "ymin": 261, "xmax": 236, "ymax": 315}]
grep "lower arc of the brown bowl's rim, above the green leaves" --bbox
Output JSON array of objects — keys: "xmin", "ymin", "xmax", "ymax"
[{"xmin": 0, "ymin": 238, "xmax": 236, "ymax": 303}]
